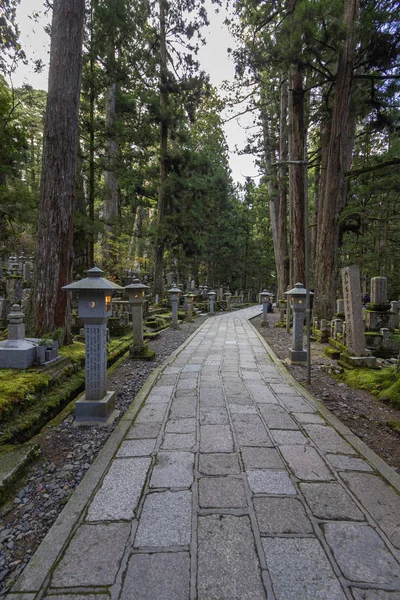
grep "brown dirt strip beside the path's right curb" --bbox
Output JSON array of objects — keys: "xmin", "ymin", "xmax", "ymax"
[{"xmin": 252, "ymin": 313, "xmax": 400, "ymax": 473}]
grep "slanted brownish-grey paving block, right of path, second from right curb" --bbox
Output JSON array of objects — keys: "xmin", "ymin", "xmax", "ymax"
[{"xmin": 300, "ymin": 483, "xmax": 365, "ymax": 521}]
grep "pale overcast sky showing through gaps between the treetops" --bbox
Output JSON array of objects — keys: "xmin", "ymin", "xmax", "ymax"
[{"xmin": 13, "ymin": 0, "xmax": 257, "ymax": 182}]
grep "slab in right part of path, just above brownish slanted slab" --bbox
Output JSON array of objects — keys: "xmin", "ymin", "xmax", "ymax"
[{"xmin": 280, "ymin": 445, "xmax": 335, "ymax": 481}]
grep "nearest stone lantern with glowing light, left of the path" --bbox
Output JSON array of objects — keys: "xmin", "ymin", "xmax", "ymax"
[{"xmin": 62, "ymin": 267, "xmax": 124, "ymax": 424}]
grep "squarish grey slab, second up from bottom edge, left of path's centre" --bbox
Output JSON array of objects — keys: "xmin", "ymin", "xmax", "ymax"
[{"xmin": 134, "ymin": 491, "xmax": 192, "ymax": 548}]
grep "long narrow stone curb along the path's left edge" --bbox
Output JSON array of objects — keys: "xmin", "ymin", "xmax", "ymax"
[{"xmin": 7, "ymin": 324, "xmax": 203, "ymax": 600}]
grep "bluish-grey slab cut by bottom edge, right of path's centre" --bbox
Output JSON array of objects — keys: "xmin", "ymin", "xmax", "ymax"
[{"xmin": 262, "ymin": 538, "xmax": 346, "ymax": 600}]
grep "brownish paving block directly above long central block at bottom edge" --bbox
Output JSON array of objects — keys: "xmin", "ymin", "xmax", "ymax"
[{"xmin": 199, "ymin": 477, "xmax": 247, "ymax": 508}]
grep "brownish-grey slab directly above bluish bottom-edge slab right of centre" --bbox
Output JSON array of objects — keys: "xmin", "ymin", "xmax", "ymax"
[{"xmin": 253, "ymin": 497, "xmax": 313, "ymax": 535}]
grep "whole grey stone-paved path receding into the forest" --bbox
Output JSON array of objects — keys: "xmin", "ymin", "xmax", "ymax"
[{"xmin": 8, "ymin": 307, "xmax": 400, "ymax": 600}]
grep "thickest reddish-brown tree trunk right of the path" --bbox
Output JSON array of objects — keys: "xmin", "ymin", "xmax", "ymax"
[{"xmin": 314, "ymin": 0, "xmax": 359, "ymax": 319}]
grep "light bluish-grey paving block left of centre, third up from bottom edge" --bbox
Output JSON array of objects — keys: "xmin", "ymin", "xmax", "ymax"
[{"xmin": 150, "ymin": 452, "xmax": 194, "ymax": 488}]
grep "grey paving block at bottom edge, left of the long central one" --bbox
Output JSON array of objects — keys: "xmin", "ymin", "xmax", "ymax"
[{"xmin": 121, "ymin": 552, "xmax": 190, "ymax": 600}]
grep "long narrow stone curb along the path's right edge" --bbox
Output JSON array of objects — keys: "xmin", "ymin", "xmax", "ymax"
[{"xmin": 249, "ymin": 315, "xmax": 400, "ymax": 493}]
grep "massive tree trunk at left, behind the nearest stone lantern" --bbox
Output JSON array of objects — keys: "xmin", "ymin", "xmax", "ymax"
[{"xmin": 33, "ymin": 0, "xmax": 85, "ymax": 339}]
